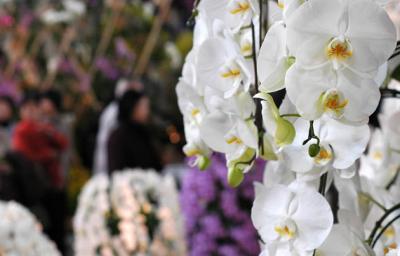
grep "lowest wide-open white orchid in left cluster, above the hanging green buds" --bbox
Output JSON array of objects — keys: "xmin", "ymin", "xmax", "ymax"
[{"xmin": 200, "ymin": 111, "xmax": 258, "ymax": 159}]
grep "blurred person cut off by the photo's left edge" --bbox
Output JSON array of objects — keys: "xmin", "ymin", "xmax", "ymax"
[{"xmin": 0, "ymin": 96, "xmax": 15, "ymax": 154}]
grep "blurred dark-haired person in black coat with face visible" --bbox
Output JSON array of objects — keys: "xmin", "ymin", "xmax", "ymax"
[{"xmin": 108, "ymin": 90, "xmax": 162, "ymax": 174}]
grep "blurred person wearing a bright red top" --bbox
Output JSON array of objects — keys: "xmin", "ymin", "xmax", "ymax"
[{"xmin": 11, "ymin": 93, "xmax": 68, "ymax": 251}]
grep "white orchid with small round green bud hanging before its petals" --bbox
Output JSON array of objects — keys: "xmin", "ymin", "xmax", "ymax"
[{"xmin": 282, "ymin": 118, "xmax": 370, "ymax": 178}]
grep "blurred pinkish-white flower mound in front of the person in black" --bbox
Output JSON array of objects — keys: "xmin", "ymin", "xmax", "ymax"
[{"xmin": 74, "ymin": 170, "xmax": 185, "ymax": 256}]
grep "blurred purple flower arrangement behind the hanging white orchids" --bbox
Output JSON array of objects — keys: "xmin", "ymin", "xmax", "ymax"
[{"xmin": 181, "ymin": 154, "xmax": 264, "ymax": 256}]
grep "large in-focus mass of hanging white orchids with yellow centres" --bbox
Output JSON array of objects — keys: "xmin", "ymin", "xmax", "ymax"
[{"xmin": 176, "ymin": 0, "xmax": 400, "ymax": 256}]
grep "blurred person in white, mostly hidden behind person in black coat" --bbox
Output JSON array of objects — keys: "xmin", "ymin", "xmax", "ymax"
[{"xmin": 93, "ymin": 79, "xmax": 143, "ymax": 174}]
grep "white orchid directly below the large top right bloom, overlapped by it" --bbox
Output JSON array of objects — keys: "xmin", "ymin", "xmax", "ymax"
[{"xmin": 286, "ymin": 61, "xmax": 380, "ymax": 124}]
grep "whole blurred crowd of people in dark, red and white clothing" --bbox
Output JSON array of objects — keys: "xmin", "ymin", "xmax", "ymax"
[{"xmin": 0, "ymin": 80, "xmax": 180, "ymax": 252}]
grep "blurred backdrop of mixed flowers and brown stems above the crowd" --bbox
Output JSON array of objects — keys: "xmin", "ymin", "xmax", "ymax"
[{"xmin": 0, "ymin": 0, "xmax": 191, "ymax": 106}]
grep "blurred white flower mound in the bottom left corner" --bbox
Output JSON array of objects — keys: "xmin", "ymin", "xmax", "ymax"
[{"xmin": 0, "ymin": 201, "xmax": 61, "ymax": 256}]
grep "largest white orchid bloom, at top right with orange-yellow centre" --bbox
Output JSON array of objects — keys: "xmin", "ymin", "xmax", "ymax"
[{"xmin": 287, "ymin": 0, "xmax": 396, "ymax": 73}]
